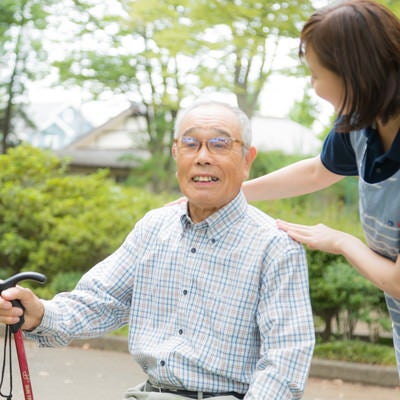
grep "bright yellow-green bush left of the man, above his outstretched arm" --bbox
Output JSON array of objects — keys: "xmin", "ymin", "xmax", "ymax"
[{"xmin": 0, "ymin": 145, "xmax": 170, "ymax": 296}]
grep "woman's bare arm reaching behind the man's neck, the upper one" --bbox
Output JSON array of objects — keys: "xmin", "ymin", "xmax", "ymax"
[{"xmin": 242, "ymin": 156, "xmax": 344, "ymax": 201}]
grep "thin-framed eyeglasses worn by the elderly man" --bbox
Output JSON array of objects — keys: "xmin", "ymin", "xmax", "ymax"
[{"xmin": 174, "ymin": 136, "xmax": 244, "ymax": 154}]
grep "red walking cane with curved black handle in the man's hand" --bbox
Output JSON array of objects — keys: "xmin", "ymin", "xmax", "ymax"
[{"xmin": 0, "ymin": 272, "xmax": 46, "ymax": 400}]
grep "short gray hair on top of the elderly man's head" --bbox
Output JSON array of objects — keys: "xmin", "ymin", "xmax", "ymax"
[{"xmin": 174, "ymin": 100, "xmax": 252, "ymax": 150}]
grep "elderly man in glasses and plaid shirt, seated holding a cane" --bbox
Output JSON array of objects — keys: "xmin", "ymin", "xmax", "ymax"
[{"xmin": 0, "ymin": 102, "xmax": 314, "ymax": 400}]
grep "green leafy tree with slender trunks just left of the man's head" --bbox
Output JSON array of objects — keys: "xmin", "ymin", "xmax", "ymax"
[{"xmin": 56, "ymin": 0, "xmax": 202, "ymax": 191}]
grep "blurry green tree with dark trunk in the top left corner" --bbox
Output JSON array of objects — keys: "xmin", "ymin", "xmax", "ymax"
[{"xmin": 0, "ymin": 0, "xmax": 99, "ymax": 153}]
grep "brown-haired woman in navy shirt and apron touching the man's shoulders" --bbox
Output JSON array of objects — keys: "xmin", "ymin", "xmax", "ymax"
[{"xmin": 243, "ymin": 0, "xmax": 400, "ymax": 375}]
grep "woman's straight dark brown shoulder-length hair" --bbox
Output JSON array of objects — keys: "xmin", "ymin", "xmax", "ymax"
[{"xmin": 299, "ymin": 0, "xmax": 400, "ymax": 132}]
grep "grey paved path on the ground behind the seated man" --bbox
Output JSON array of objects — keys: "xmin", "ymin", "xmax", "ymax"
[{"xmin": 5, "ymin": 341, "xmax": 400, "ymax": 400}]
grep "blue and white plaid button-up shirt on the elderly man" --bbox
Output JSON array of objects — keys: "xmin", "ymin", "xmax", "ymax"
[{"xmin": 29, "ymin": 193, "xmax": 314, "ymax": 400}]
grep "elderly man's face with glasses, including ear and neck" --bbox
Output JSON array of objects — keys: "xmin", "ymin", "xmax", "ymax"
[{"xmin": 172, "ymin": 104, "xmax": 256, "ymax": 222}]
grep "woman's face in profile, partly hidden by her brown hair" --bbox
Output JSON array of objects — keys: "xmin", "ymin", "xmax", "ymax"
[{"xmin": 305, "ymin": 46, "xmax": 344, "ymax": 112}]
